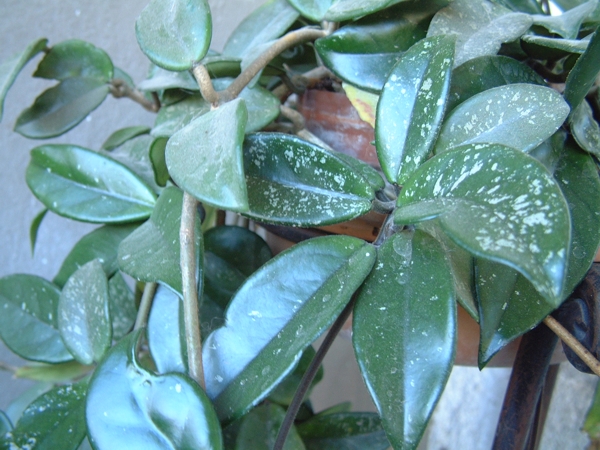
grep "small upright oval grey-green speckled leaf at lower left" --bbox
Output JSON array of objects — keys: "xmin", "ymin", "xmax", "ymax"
[{"xmin": 58, "ymin": 259, "xmax": 112, "ymax": 364}]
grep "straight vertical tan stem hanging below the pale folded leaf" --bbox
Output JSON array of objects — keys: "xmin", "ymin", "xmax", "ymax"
[{"xmin": 179, "ymin": 192, "xmax": 205, "ymax": 389}]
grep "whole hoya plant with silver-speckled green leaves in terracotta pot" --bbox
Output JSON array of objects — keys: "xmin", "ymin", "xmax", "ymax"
[{"xmin": 0, "ymin": 0, "xmax": 600, "ymax": 450}]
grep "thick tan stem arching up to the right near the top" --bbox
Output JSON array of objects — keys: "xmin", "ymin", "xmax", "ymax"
[{"xmin": 222, "ymin": 28, "xmax": 327, "ymax": 101}]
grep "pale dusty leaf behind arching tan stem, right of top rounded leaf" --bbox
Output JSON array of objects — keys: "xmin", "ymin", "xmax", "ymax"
[{"xmin": 223, "ymin": 0, "xmax": 299, "ymax": 58}]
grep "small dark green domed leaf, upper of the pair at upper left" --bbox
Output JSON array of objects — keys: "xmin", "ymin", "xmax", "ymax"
[{"xmin": 33, "ymin": 39, "xmax": 114, "ymax": 83}]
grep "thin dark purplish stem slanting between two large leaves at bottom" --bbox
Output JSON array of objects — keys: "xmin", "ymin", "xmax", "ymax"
[{"xmin": 273, "ymin": 295, "xmax": 356, "ymax": 450}]
